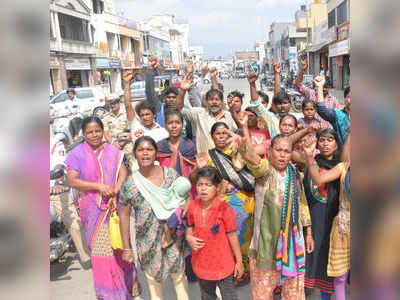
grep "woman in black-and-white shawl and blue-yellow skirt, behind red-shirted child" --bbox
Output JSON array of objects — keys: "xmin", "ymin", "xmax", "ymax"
[{"xmin": 192, "ymin": 122, "xmax": 255, "ymax": 285}]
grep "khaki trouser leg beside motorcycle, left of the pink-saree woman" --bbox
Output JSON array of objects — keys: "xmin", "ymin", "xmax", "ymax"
[{"xmin": 50, "ymin": 193, "xmax": 90, "ymax": 262}]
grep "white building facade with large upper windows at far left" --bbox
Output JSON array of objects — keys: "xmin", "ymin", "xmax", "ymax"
[{"xmin": 49, "ymin": 0, "xmax": 96, "ymax": 94}]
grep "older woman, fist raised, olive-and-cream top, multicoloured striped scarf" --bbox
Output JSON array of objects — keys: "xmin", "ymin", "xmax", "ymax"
[{"xmin": 236, "ymin": 132, "xmax": 314, "ymax": 300}]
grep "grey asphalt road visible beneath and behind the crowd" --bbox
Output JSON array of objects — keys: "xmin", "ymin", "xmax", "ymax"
[{"xmin": 50, "ymin": 79, "xmax": 343, "ymax": 300}]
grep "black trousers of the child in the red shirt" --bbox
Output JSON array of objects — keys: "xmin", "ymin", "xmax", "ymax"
[{"xmin": 199, "ymin": 274, "xmax": 238, "ymax": 300}]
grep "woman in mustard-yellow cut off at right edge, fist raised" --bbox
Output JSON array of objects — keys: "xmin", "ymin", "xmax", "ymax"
[{"xmin": 303, "ymin": 136, "xmax": 351, "ymax": 300}]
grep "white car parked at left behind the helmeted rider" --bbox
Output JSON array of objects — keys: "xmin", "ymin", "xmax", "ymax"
[{"xmin": 49, "ymin": 87, "xmax": 105, "ymax": 119}]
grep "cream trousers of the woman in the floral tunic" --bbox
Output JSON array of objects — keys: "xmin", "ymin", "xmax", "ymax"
[{"xmin": 144, "ymin": 268, "xmax": 189, "ymax": 300}]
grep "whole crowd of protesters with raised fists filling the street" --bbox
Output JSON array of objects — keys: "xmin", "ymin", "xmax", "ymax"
[{"xmin": 53, "ymin": 57, "xmax": 351, "ymax": 300}]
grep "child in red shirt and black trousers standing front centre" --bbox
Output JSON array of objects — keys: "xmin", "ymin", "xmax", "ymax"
[{"xmin": 186, "ymin": 167, "xmax": 243, "ymax": 300}]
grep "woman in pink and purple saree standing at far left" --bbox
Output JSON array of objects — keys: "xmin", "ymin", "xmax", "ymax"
[{"xmin": 65, "ymin": 117, "xmax": 139, "ymax": 300}]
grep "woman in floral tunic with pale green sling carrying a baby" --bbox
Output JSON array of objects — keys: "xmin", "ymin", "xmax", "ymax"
[{"xmin": 120, "ymin": 136, "xmax": 189, "ymax": 300}]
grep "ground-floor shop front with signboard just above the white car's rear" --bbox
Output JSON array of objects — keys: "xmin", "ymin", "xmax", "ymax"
[{"xmin": 96, "ymin": 57, "xmax": 122, "ymax": 93}]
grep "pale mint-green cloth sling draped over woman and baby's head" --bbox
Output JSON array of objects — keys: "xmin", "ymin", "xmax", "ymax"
[{"xmin": 132, "ymin": 171, "xmax": 192, "ymax": 220}]
